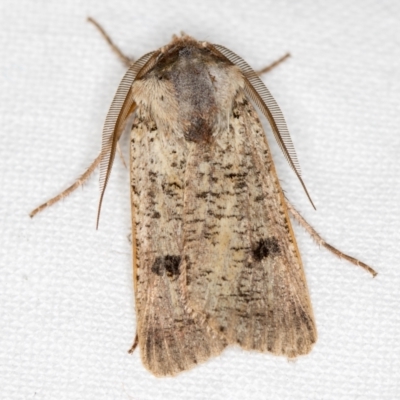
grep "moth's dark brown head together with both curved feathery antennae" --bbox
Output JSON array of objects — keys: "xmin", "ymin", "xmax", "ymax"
[{"xmin": 97, "ymin": 34, "xmax": 315, "ymax": 225}]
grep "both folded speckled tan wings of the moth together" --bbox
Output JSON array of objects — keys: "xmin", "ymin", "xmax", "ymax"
[{"xmin": 131, "ymin": 93, "xmax": 316, "ymax": 375}]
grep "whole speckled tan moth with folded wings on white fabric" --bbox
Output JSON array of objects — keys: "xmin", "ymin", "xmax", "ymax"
[{"xmin": 32, "ymin": 20, "xmax": 376, "ymax": 376}]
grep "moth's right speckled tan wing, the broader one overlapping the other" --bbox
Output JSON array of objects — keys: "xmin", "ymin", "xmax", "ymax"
[{"xmin": 181, "ymin": 94, "xmax": 317, "ymax": 357}]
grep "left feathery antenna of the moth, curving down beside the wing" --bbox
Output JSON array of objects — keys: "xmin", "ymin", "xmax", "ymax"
[{"xmin": 96, "ymin": 52, "xmax": 158, "ymax": 229}]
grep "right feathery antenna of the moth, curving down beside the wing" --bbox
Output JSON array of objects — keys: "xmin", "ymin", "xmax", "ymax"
[{"xmin": 212, "ymin": 44, "xmax": 316, "ymax": 209}]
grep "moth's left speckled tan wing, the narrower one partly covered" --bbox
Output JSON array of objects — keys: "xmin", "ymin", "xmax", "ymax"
[{"xmin": 131, "ymin": 109, "xmax": 226, "ymax": 376}]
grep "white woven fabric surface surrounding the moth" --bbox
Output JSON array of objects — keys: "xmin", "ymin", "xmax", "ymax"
[{"xmin": 0, "ymin": 0, "xmax": 400, "ymax": 400}]
